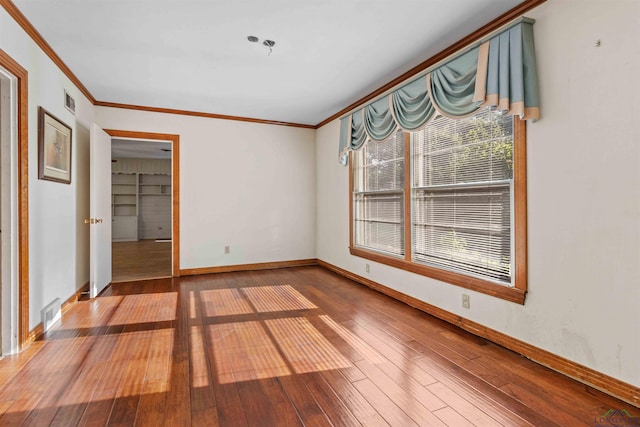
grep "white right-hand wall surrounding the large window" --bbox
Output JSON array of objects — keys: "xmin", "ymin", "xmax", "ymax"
[{"xmin": 316, "ymin": 0, "xmax": 640, "ymax": 386}]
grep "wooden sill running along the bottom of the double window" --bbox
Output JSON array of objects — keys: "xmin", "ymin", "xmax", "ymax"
[{"xmin": 349, "ymin": 246, "xmax": 526, "ymax": 305}]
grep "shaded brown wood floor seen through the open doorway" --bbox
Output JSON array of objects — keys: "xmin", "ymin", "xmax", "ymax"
[{"xmin": 111, "ymin": 240, "xmax": 171, "ymax": 283}]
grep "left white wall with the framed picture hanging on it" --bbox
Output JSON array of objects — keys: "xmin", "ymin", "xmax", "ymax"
[{"xmin": 0, "ymin": 8, "xmax": 93, "ymax": 328}]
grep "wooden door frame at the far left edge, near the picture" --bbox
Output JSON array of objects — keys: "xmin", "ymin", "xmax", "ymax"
[{"xmin": 0, "ymin": 49, "xmax": 29, "ymax": 350}]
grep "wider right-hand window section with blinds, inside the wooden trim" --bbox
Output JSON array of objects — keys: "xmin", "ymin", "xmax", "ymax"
[{"xmin": 412, "ymin": 109, "xmax": 513, "ymax": 284}]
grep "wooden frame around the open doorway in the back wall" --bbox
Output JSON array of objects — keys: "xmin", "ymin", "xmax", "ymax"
[{"xmin": 104, "ymin": 129, "xmax": 180, "ymax": 277}]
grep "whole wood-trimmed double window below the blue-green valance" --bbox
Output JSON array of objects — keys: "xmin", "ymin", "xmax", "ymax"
[{"xmin": 351, "ymin": 108, "xmax": 526, "ymax": 303}]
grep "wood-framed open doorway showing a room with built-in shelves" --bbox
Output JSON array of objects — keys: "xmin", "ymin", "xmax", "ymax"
[{"xmin": 106, "ymin": 130, "xmax": 179, "ymax": 283}]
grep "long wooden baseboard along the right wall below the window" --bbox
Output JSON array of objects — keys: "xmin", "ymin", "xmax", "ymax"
[{"xmin": 317, "ymin": 260, "xmax": 640, "ymax": 407}]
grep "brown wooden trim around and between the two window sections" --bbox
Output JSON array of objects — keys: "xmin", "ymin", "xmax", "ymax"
[{"xmin": 349, "ymin": 117, "xmax": 527, "ymax": 304}]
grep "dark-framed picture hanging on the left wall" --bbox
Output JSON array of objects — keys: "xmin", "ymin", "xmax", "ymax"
[{"xmin": 38, "ymin": 107, "xmax": 72, "ymax": 184}]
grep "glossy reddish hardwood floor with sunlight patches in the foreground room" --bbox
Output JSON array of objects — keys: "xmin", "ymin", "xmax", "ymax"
[{"xmin": 0, "ymin": 267, "xmax": 640, "ymax": 426}]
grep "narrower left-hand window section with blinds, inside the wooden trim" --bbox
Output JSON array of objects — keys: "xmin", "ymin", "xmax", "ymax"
[{"xmin": 353, "ymin": 132, "xmax": 404, "ymax": 256}]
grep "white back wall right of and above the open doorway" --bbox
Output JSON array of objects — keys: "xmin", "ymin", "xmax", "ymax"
[{"xmin": 96, "ymin": 107, "xmax": 316, "ymax": 269}]
